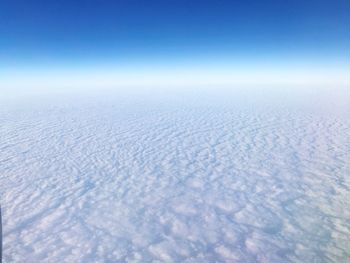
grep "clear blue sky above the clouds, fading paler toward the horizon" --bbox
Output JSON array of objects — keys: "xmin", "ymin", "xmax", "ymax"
[{"xmin": 0, "ymin": 0, "xmax": 350, "ymax": 88}]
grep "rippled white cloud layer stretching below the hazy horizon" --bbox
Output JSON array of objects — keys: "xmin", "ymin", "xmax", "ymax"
[{"xmin": 0, "ymin": 89, "xmax": 350, "ymax": 262}]
